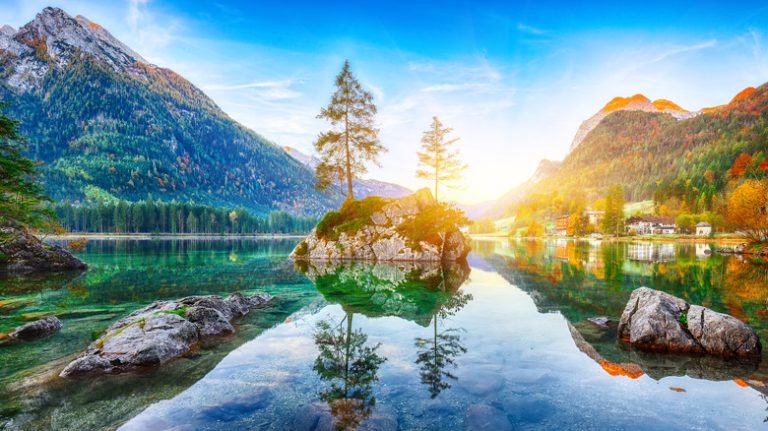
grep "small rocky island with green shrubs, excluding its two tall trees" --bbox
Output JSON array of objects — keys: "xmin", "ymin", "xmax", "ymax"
[{"xmin": 291, "ymin": 189, "xmax": 470, "ymax": 262}]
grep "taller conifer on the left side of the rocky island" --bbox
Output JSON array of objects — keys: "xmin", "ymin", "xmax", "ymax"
[{"xmin": 314, "ymin": 60, "xmax": 386, "ymax": 199}]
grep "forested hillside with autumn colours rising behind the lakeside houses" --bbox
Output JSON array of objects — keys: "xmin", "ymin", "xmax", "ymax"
[{"xmin": 516, "ymin": 84, "xmax": 768, "ymax": 211}]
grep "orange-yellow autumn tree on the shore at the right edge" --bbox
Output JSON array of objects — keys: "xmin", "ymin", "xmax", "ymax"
[{"xmin": 728, "ymin": 179, "xmax": 768, "ymax": 242}]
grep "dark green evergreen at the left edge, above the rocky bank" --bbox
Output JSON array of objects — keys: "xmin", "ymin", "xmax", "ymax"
[{"xmin": 0, "ymin": 103, "xmax": 55, "ymax": 227}]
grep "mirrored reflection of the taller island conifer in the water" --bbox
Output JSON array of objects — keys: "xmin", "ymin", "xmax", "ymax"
[{"xmin": 314, "ymin": 313, "xmax": 386, "ymax": 430}]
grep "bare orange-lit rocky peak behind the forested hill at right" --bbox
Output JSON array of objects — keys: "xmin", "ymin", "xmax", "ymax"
[{"xmin": 570, "ymin": 94, "xmax": 698, "ymax": 151}]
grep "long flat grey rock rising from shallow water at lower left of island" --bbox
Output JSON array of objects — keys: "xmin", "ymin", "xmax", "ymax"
[{"xmin": 60, "ymin": 293, "xmax": 272, "ymax": 377}]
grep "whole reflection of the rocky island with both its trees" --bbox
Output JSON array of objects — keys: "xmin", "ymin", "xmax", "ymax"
[{"xmin": 296, "ymin": 261, "xmax": 472, "ymax": 422}]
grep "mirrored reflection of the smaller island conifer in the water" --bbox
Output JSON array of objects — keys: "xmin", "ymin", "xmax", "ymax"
[{"xmin": 416, "ymin": 291, "xmax": 472, "ymax": 398}]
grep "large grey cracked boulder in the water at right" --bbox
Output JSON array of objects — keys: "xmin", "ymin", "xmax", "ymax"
[{"xmin": 618, "ymin": 287, "xmax": 761, "ymax": 358}]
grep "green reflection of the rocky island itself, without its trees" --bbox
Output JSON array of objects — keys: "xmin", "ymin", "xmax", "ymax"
[{"xmin": 296, "ymin": 261, "xmax": 470, "ymax": 326}]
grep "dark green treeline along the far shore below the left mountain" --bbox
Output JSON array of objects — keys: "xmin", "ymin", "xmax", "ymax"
[{"xmin": 54, "ymin": 198, "xmax": 317, "ymax": 234}]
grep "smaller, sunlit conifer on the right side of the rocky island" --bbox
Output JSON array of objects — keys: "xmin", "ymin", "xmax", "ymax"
[{"xmin": 416, "ymin": 117, "xmax": 467, "ymax": 200}]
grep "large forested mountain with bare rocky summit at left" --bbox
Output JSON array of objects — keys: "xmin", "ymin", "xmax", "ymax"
[{"xmin": 0, "ymin": 8, "xmax": 341, "ymax": 214}]
